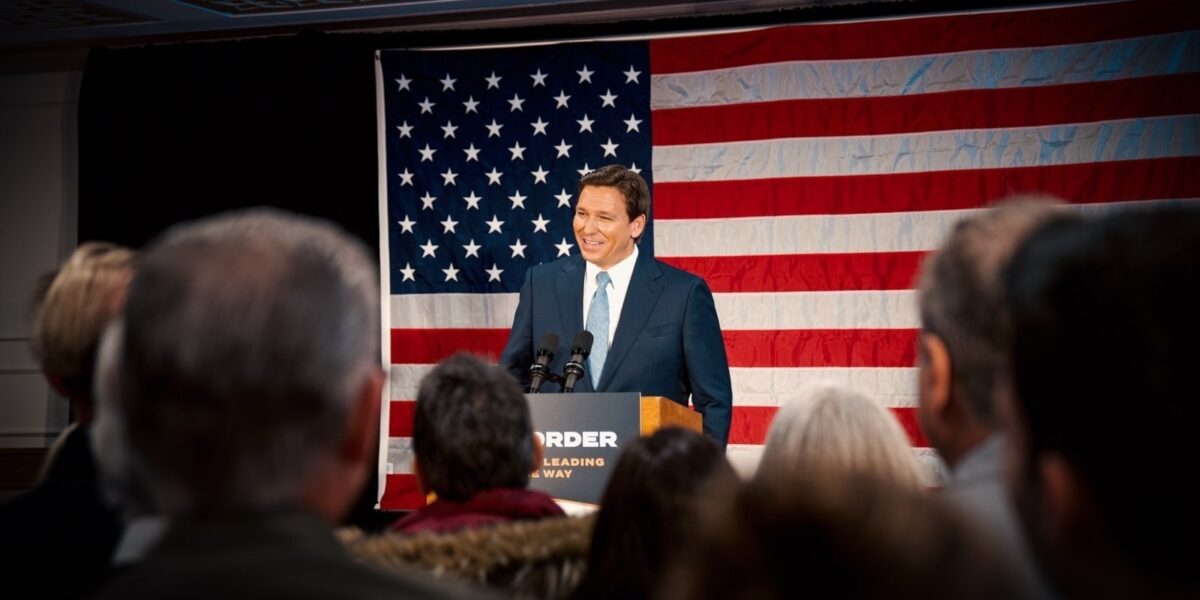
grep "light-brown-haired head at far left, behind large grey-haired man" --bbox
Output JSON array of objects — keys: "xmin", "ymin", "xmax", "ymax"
[{"xmin": 30, "ymin": 241, "xmax": 133, "ymax": 424}]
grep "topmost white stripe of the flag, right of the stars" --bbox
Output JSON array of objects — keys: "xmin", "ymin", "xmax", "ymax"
[{"xmin": 650, "ymin": 31, "xmax": 1200, "ymax": 109}]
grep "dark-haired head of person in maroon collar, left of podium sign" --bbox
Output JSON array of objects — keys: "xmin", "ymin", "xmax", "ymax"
[{"xmin": 413, "ymin": 354, "xmax": 534, "ymax": 500}]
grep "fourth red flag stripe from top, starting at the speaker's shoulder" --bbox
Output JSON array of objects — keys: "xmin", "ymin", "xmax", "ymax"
[{"xmin": 660, "ymin": 252, "xmax": 926, "ymax": 292}]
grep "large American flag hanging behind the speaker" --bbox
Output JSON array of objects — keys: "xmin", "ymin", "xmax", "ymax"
[{"xmin": 377, "ymin": 1, "xmax": 1200, "ymax": 509}]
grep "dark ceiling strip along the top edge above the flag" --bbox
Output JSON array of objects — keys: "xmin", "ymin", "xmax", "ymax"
[{"xmin": 0, "ymin": 0, "xmax": 864, "ymax": 50}]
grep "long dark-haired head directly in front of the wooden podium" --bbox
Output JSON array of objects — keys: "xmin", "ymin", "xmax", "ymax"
[{"xmin": 576, "ymin": 427, "xmax": 737, "ymax": 598}]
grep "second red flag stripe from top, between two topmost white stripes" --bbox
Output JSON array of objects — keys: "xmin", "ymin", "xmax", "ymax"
[{"xmin": 652, "ymin": 73, "xmax": 1200, "ymax": 145}]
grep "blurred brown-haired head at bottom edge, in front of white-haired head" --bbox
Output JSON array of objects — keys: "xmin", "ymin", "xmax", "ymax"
[{"xmin": 660, "ymin": 472, "xmax": 1015, "ymax": 600}]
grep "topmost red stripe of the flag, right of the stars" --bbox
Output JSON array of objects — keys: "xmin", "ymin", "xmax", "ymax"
[{"xmin": 650, "ymin": 1, "xmax": 1200, "ymax": 76}]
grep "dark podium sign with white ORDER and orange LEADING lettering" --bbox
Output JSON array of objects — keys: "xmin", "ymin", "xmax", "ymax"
[{"xmin": 526, "ymin": 392, "xmax": 642, "ymax": 504}]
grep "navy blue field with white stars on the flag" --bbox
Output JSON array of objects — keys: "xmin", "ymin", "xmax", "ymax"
[{"xmin": 379, "ymin": 42, "xmax": 654, "ymax": 294}]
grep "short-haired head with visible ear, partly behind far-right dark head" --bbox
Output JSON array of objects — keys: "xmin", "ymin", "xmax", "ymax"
[{"xmin": 917, "ymin": 198, "xmax": 1078, "ymax": 467}]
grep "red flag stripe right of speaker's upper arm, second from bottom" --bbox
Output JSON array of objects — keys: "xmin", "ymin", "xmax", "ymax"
[{"xmin": 721, "ymin": 329, "xmax": 917, "ymax": 367}]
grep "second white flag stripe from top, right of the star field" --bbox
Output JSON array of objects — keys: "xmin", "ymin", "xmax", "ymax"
[{"xmin": 654, "ymin": 114, "xmax": 1200, "ymax": 180}]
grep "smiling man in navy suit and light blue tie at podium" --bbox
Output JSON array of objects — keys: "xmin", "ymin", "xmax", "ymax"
[{"xmin": 500, "ymin": 164, "xmax": 733, "ymax": 448}]
